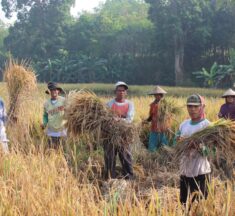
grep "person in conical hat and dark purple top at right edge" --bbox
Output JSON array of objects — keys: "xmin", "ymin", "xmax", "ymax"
[{"xmin": 218, "ymin": 89, "xmax": 235, "ymax": 121}]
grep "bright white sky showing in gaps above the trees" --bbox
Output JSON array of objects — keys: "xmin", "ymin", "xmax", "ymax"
[{"xmin": 0, "ymin": 0, "xmax": 105, "ymax": 23}]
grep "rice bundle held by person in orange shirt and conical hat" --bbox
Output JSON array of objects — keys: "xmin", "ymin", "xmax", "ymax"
[{"xmin": 157, "ymin": 98, "xmax": 181, "ymax": 131}]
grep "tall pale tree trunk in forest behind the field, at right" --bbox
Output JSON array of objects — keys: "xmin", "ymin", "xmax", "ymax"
[{"xmin": 174, "ymin": 35, "xmax": 184, "ymax": 85}]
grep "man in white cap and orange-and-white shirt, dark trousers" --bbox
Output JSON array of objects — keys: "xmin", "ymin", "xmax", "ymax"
[{"xmin": 104, "ymin": 82, "xmax": 134, "ymax": 179}]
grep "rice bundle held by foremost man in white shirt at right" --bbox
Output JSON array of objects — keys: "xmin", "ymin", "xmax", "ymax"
[{"xmin": 175, "ymin": 119, "xmax": 235, "ymax": 170}]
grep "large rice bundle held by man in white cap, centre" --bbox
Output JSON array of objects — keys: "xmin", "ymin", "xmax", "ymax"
[{"xmin": 65, "ymin": 91, "xmax": 136, "ymax": 147}]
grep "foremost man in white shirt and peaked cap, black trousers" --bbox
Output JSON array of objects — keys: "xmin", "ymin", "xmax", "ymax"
[{"xmin": 179, "ymin": 94, "xmax": 211, "ymax": 204}]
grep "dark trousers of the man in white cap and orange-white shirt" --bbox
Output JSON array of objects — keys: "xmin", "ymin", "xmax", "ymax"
[{"xmin": 104, "ymin": 143, "xmax": 133, "ymax": 179}]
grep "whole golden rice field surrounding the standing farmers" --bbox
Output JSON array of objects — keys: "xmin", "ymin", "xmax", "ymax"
[{"xmin": 0, "ymin": 83, "xmax": 235, "ymax": 216}]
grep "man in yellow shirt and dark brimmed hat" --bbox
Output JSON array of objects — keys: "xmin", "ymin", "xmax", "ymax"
[{"xmin": 42, "ymin": 82, "xmax": 67, "ymax": 149}]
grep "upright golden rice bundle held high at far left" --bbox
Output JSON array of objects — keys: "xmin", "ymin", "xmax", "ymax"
[{"xmin": 4, "ymin": 59, "xmax": 37, "ymax": 121}]
